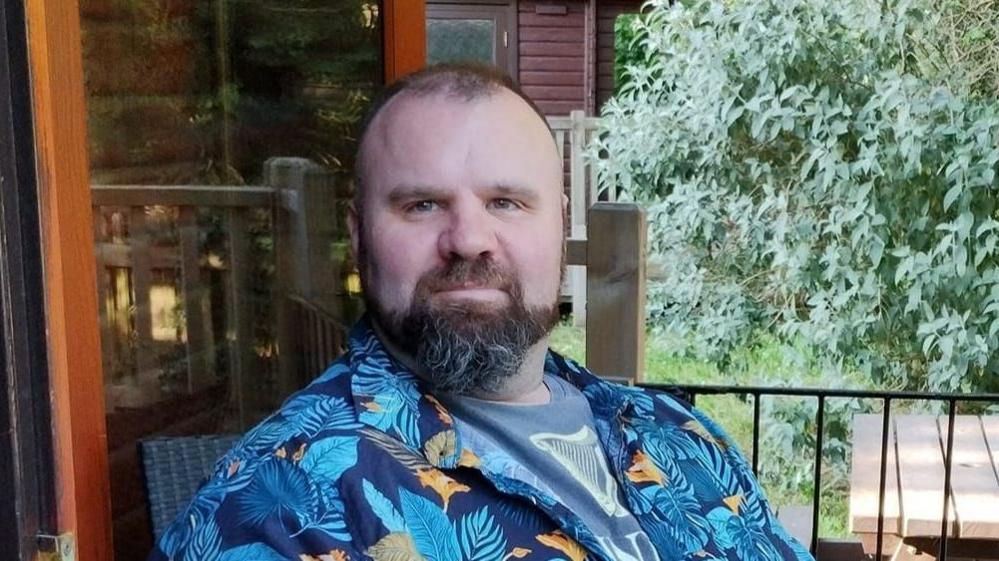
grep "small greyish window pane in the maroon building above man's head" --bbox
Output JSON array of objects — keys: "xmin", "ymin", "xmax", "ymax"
[{"xmin": 427, "ymin": 19, "xmax": 496, "ymax": 64}]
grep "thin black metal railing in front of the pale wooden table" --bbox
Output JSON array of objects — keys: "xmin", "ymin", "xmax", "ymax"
[{"xmin": 636, "ymin": 383, "xmax": 999, "ymax": 561}]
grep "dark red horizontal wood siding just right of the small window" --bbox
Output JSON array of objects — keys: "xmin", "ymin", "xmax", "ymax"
[{"xmin": 517, "ymin": 0, "xmax": 586, "ymax": 116}]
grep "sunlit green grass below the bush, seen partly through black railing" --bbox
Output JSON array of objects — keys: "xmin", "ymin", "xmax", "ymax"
[{"xmin": 549, "ymin": 323, "xmax": 860, "ymax": 546}]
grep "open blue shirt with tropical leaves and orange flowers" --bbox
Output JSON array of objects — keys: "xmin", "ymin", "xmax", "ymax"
[{"xmin": 150, "ymin": 321, "xmax": 812, "ymax": 561}]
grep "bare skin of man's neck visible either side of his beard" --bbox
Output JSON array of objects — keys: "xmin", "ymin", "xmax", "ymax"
[{"xmin": 371, "ymin": 320, "xmax": 551, "ymax": 405}]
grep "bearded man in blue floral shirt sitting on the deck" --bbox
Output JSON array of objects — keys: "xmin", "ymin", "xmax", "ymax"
[{"xmin": 153, "ymin": 66, "xmax": 810, "ymax": 561}]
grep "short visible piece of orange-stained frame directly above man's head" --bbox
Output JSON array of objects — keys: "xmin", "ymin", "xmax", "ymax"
[{"xmin": 382, "ymin": 0, "xmax": 427, "ymax": 84}]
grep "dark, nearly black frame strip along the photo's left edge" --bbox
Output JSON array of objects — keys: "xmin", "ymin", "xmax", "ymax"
[{"xmin": 0, "ymin": 0, "xmax": 56, "ymax": 561}]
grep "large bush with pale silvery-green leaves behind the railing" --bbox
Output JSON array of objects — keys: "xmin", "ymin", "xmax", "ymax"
[{"xmin": 595, "ymin": 0, "xmax": 999, "ymax": 391}]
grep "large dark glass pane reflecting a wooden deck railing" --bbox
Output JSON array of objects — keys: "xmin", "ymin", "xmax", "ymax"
[{"xmin": 80, "ymin": 0, "xmax": 383, "ymax": 561}]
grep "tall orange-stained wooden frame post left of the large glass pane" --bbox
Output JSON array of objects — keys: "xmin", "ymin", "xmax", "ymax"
[{"xmin": 26, "ymin": 0, "xmax": 112, "ymax": 561}]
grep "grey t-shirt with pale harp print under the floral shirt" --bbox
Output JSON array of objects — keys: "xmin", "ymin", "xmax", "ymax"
[{"xmin": 442, "ymin": 374, "xmax": 658, "ymax": 561}]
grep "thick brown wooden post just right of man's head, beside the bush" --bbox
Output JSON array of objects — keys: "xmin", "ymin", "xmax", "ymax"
[{"xmin": 586, "ymin": 203, "xmax": 646, "ymax": 382}]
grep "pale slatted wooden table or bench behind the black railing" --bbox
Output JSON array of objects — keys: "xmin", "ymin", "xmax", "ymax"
[{"xmin": 850, "ymin": 415, "xmax": 999, "ymax": 561}]
